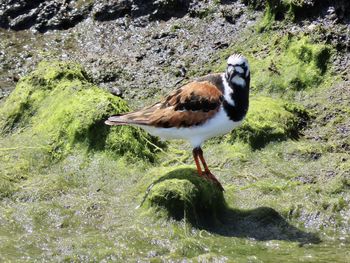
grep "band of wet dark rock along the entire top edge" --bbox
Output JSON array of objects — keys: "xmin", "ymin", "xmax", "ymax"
[{"xmin": 0, "ymin": 0, "xmax": 350, "ymax": 31}]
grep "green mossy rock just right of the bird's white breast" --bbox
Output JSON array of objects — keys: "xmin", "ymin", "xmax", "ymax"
[{"xmin": 230, "ymin": 97, "xmax": 309, "ymax": 149}]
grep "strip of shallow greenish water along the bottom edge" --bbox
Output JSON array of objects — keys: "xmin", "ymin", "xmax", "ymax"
[{"xmin": 0, "ymin": 204, "xmax": 350, "ymax": 262}]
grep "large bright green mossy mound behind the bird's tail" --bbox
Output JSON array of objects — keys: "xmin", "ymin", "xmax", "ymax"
[{"xmin": 0, "ymin": 62, "xmax": 159, "ymax": 160}]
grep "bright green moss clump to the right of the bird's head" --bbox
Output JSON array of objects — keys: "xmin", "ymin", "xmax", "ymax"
[{"xmin": 250, "ymin": 36, "xmax": 331, "ymax": 92}]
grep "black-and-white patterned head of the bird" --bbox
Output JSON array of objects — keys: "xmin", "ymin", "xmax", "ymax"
[{"xmin": 225, "ymin": 54, "xmax": 250, "ymax": 86}]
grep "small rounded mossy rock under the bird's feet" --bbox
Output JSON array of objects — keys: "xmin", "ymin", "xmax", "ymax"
[{"xmin": 145, "ymin": 168, "xmax": 226, "ymax": 225}]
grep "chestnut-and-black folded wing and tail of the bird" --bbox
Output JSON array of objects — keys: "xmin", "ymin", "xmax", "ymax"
[{"xmin": 106, "ymin": 81, "xmax": 223, "ymax": 128}]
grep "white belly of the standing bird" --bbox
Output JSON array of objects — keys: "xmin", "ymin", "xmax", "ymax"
[{"xmin": 140, "ymin": 107, "xmax": 242, "ymax": 147}]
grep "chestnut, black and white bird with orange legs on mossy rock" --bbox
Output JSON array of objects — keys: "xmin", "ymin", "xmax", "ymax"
[{"xmin": 105, "ymin": 53, "xmax": 250, "ymax": 191}]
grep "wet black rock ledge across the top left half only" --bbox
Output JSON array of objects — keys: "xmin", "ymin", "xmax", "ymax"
[{"xmin": 0, "ymin": 0, "xmax": 191, "ymax": 32}]
